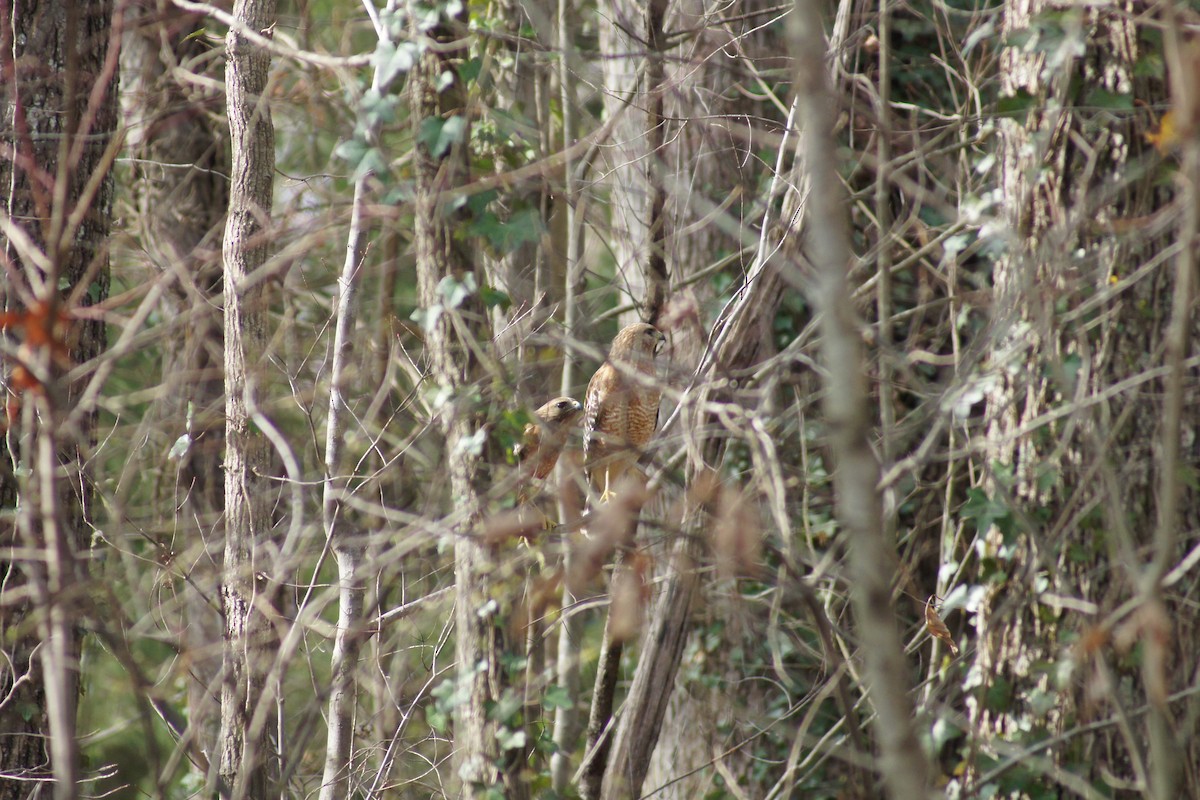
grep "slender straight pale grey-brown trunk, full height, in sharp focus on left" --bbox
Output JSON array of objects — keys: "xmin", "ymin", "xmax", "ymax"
[{"xmin": 218, "ymin": 0, "xmax": 277, "ymax": 798}]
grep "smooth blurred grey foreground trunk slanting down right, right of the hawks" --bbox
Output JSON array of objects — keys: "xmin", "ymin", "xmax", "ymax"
[{"xmin": 788, "ymin": 0, "xmax": 929, "ymax": 800}]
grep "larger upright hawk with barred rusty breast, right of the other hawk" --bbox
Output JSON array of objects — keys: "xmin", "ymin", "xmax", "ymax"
[{"xmin": 583, "ymin": 323, "xmax": 666, "ymax": 500}]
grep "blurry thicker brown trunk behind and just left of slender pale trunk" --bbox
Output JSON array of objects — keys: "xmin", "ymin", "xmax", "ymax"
[{"xmin": 121, "ymin": 2, "xmax": 229, "ymax": 751}]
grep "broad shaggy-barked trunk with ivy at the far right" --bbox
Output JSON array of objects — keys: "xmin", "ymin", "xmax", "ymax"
[{"xmin": 966, "ymin": 1, "xmax": 1200, "ymax": 798}]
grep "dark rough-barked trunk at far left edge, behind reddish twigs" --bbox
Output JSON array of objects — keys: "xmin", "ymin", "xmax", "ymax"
[{"xmin": 0, "ymin": 0, "xmax": 116, "ymax": 799}]
